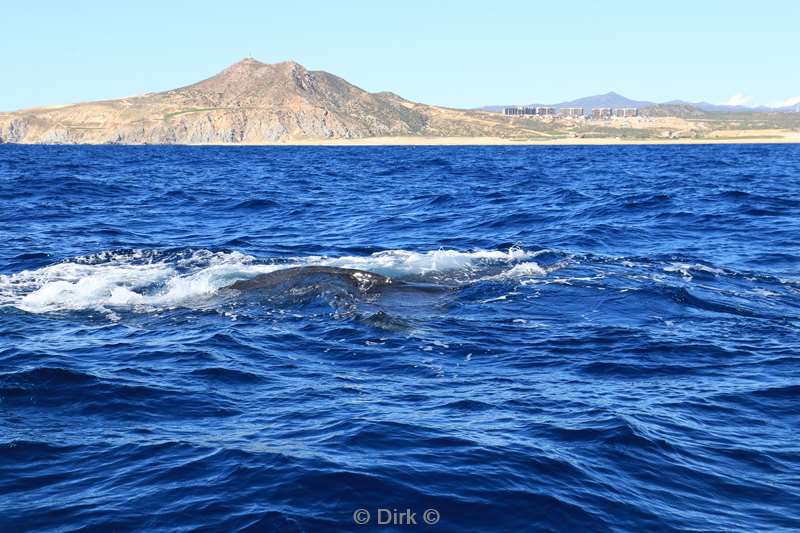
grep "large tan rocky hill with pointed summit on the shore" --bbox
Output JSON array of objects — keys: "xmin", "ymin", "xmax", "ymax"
[{"xmin": 0, "ymin": 59, "xmax": 519, "ymax": 144}]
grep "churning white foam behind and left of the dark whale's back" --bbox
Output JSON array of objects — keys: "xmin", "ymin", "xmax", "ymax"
[{"xmin": 0, "ymin": 248, "xmax": 545, "ymax": 314}]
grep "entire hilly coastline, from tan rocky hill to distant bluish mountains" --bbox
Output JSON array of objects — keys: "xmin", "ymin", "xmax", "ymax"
[{"xmin": 0, "ymin": 58, "xmax": 800, "ymax": 144}]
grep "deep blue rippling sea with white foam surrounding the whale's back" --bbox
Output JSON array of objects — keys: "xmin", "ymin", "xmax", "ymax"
[{"xmin": 0, "ymin": 145, "xmax": 800, "ymax": 531}]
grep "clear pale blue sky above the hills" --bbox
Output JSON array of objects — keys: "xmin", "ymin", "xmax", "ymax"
[{"xmin": 0, "ymin": 0, "xmax": 800, "ymax": 111}]
